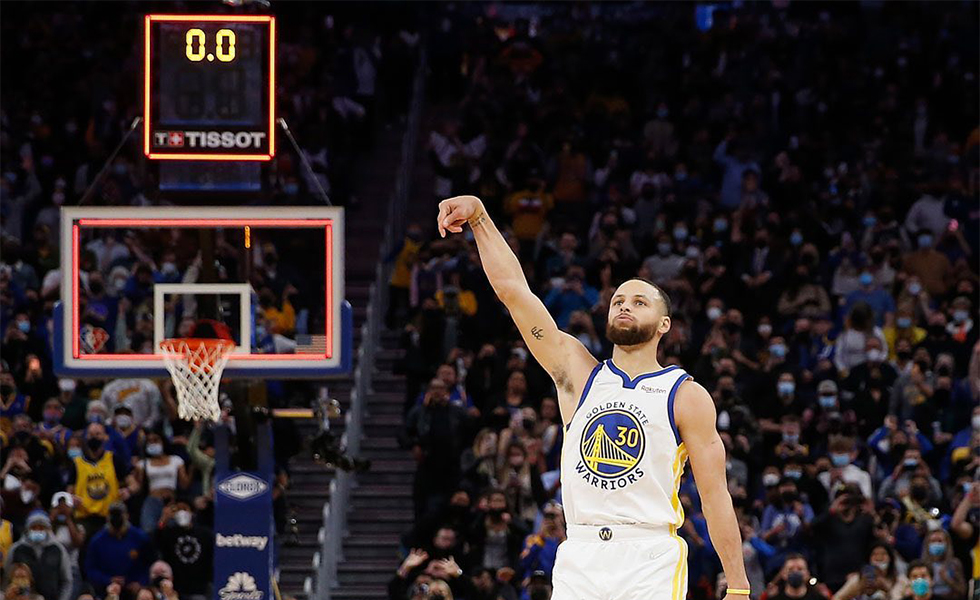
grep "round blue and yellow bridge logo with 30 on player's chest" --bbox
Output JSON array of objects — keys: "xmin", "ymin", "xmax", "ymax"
[{"xmin": 576, "ymin": 409, "xmax": 646, "ymax": 490}]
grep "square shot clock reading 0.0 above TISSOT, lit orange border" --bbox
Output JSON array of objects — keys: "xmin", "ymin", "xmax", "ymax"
[{"xmin": 143, "ymin": 15, "xmax": 276, "ymax": 161}]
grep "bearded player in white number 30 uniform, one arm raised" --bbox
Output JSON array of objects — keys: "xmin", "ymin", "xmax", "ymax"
[{"xmin": 438, "ymin": 196, "xmax": 749, "ymax": 600}]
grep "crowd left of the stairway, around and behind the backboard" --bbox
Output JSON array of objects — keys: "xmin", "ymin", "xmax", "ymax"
[{"xmin": 0, "ymin": 3, "xmax": 418, "ymax": 600}]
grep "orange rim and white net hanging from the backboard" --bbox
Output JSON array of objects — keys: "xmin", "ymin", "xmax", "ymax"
[{"xmin": 160, "ymin": 338, "xmax": 235, "ymax": 422}]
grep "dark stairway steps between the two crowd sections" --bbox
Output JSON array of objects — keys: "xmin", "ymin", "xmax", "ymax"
[{"xmin": 278, "ymin": 126, "xmax": 411, "ymax": 600}]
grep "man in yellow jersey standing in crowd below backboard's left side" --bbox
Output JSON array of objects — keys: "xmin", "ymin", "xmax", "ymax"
[{"xmin": 68, "ymin": 423, "xmax": 129, "ymax": 537}]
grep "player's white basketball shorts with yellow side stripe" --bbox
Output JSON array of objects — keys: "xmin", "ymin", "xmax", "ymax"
[{"xmin": 551, "ymin": 525, "xmax": 687, "ymax": 600}]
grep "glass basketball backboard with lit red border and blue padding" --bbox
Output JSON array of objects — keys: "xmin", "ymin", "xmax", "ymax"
[{"xmin": 54, "ymin": 206, "xmax": 352, "ymax": 378}]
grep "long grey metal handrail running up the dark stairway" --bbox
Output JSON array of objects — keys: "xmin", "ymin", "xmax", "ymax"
[{"xmin": 313, "ymin": 44, "xmax": 428, "ymax": 600}]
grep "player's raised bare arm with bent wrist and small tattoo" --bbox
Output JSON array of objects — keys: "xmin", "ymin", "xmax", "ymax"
[{"xmin": 438, "ymin": 196, "xmax": 597, "ymax": 423}]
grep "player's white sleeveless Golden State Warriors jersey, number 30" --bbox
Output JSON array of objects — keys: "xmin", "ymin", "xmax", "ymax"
[{"xmin": 561, "ymin": 360, "xmax": 690, "ymax": 527}]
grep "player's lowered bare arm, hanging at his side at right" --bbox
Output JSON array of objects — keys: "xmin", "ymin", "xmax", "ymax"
[{"xmin": 674, "ymin": 381, "xmax": 759, "ymax": 600}]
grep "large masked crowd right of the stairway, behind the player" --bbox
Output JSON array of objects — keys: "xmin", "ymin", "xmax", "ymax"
[{"xmin": 389, "ymin": 2, "xmax": 980, "ymax": 600}]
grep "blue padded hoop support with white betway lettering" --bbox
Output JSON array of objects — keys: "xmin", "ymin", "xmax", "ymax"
[{"xmin": 214, "ymin": 427, "xmax": 275, "ymax": 600}]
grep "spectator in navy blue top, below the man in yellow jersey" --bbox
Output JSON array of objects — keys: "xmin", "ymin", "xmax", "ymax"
[{"xmin": 85, "ymin": 502, "xmax": 155, "ymax": 594}]
